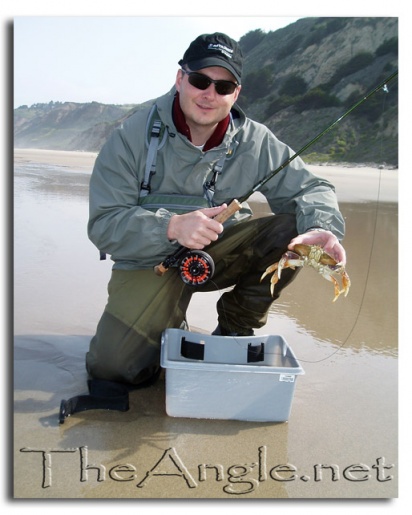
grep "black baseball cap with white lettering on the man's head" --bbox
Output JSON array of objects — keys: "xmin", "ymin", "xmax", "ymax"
[{"xmin": 179, "ymin": 32, "xmax": 243, "ymax": 84}]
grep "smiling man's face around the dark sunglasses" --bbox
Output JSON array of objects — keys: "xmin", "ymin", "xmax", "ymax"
[{"xmin": 176, "ymin": 66, "xmax": 241, "ymax": 134}]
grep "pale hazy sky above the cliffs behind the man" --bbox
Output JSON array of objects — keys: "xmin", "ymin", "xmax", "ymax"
[{"xmin": 13, "ymin": 16, "xmax": 298, "ymax": 107}]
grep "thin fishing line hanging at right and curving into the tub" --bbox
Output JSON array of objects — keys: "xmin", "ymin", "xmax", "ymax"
[{"xmin": 201, "ymin": 77, "xmax": 398, "ymax": 364}]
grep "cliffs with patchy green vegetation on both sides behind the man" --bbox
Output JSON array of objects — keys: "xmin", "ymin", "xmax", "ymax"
[{"xmin": 14, "ymin": 17, "xmax": 398, "ymax": 166}]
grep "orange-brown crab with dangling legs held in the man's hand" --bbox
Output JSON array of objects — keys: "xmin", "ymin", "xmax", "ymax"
[{"xmin": 260, "ymin": 243, "xmax": 350, "ymax": 302}]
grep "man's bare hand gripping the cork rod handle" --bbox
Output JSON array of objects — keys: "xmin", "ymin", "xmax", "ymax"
[{"xmin": 167, "ymin": 204, "xmax": 227, "ymax": 250}]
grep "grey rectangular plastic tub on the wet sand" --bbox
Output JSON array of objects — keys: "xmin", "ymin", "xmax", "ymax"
[{"xmin": 160, "ymin": 329, "xmax": 305, "ymax": 422}]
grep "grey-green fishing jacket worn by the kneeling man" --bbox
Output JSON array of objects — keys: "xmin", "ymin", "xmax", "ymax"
[{"xmin": 88, "ymin": 89, "xmax": 344, "ymax": 269}]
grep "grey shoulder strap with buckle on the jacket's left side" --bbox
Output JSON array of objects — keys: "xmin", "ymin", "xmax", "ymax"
[{"xmin": 140, "ymin": 104, "xmax": 167, "ymax": 197}]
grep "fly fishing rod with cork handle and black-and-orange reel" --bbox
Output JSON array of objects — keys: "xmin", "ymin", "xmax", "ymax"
[{"xmin": 154, "ymin": 71, "xmax": 398, "ymax": 286}]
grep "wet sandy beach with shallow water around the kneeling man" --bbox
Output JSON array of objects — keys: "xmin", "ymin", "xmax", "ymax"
[{"xmin": 14, "ymin": 150, "xmax": 398, "ymax": 499}]
